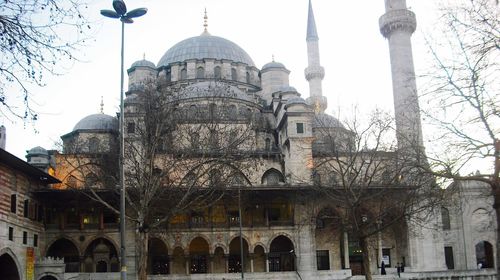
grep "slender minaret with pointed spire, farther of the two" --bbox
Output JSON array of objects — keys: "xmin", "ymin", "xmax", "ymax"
[{"xmin": 304, "ymin": 0, "xmax": 327, "ymax": 113}]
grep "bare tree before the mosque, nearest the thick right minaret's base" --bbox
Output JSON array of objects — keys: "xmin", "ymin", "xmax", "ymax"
[{"xmin": 313, "ymin": 111, "xmax": 442, "ymax": 279}]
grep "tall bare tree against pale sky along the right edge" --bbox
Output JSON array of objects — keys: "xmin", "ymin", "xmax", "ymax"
[{"xmin": 422, "ymin": 0, "xmax": 500, "ymax": 277}]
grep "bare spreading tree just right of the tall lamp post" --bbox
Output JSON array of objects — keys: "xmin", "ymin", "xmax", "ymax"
[{"xmin": 57, "ymin": 81, "xmax": 259, "ymax": 279}]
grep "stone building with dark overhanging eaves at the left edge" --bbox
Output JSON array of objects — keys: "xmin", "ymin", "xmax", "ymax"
[{"xmin": 0, "ymin": 149, "xmax": 60, "ymax": 280}]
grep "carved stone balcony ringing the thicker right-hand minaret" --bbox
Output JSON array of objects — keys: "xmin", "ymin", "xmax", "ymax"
[{"xmin": 379, "ymin": 9, "xmax": 417, "ymax": 38}]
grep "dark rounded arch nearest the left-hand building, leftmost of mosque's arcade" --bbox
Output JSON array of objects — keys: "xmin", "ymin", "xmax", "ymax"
[{"xmin": 46, "ymin": 237, "xmax": 81, "ymax": 272}]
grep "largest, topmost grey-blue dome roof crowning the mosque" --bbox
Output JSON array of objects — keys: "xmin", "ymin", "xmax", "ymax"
[{"xmin": 158, "ymin": 32, "xmax": 255, "ymax": 67}]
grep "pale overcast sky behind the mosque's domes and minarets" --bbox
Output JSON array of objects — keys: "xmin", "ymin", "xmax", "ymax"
[{"xmin": 0, "ymin": 0, "xmax": 435, "ymax": 159}]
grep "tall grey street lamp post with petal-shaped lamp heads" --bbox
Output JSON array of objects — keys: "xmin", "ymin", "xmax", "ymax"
[{"xmin": 101, "ymin": 0, "xmax": 148, "ymax": 280}]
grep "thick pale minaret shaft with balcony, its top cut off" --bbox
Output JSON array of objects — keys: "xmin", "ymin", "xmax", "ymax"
[{"xmin": 379, "ymin": 0, "xmax": 423, "ymax": 151}]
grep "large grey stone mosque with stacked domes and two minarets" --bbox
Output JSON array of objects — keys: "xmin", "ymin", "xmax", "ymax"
[{"xmin": 0, "ymin": 0, "xmax": 497, "ymax": 280}]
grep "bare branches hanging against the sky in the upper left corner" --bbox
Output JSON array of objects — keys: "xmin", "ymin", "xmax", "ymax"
[{"xmin": 0, "ymin": 0, "xmax": 90, "ymax": 120}]
